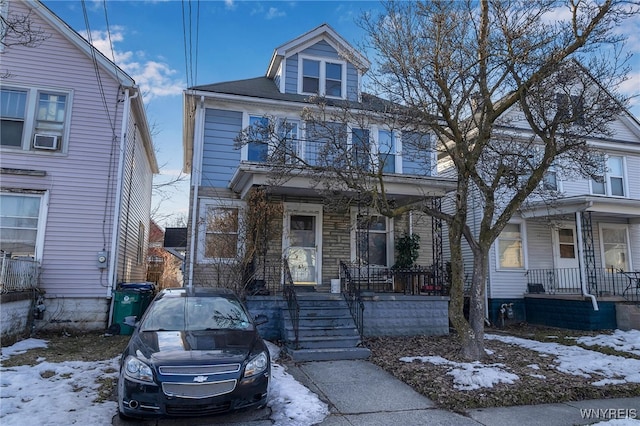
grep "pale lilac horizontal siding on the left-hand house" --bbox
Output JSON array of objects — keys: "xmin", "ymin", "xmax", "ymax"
[{"xmin": 1, "ymin": 2, "xmax": 151, "ymax": 297}]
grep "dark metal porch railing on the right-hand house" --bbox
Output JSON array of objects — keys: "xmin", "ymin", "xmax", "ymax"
[{"xmin": 525, "ymin": 268, "xmax": 640, "ymax": 301}]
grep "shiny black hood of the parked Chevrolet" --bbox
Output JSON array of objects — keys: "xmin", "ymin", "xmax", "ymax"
[{"xmin": 131, "ymin": 330, "xmax": 260, "ymax": 363}]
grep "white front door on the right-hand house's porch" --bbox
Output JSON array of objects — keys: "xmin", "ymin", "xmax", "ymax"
[{"xmin": 553, "ymin": 224, "xmax": 580, "ymax": 291}]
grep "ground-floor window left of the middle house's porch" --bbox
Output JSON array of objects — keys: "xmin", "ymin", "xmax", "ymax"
[{"xmin": 204, "ymin": 206, "xmax": 239, "ymax": 259}]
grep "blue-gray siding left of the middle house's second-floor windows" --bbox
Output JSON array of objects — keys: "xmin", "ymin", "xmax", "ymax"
[{"xmin": 200, "ymin": 109, "xmax": 242, "ymax": 188}]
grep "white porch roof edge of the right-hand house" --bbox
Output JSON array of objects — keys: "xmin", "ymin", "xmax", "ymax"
[{"xmin": 522, "ymin": 195, "xmax": 640, "ymax": 223}]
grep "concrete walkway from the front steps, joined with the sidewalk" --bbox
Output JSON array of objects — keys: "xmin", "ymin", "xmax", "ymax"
[{"xmin": 113, "ymin": 360, "xmax": 640, "ymax": 426}]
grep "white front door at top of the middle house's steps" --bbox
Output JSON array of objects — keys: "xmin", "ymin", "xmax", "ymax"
[{"xmin": 284, "ymin": 204, "xmax": 322, "ymax": 286}]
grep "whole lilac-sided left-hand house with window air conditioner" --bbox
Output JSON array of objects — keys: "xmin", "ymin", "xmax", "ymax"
[{"xmin": 0, "ymin": 1, "xmax": 158, "ymax": 329}]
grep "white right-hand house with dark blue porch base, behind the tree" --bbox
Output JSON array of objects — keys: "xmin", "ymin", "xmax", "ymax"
[{"xmin": 439, "ymin": 92, "xmax": 640, "ymax": 329}]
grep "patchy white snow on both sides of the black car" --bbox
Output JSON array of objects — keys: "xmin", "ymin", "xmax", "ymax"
[{"xmin": 0, "ymin": 339, "xmax": 329, "ymax": 426}]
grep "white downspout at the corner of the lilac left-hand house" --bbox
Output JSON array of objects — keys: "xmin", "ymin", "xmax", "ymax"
[{"xmin": 107, "ymin": 89, "xmax": 140, "ymax": 325}]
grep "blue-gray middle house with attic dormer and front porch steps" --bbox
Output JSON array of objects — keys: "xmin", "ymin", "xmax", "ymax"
[{"xmin": 183, "ymin": 24, "xmax": 454, "ymax": 359}]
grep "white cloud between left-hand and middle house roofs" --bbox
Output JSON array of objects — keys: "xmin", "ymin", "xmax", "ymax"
[{"xmin": 86, "ymin": 26, "xmax": 186, "ymax": 102}]
